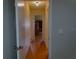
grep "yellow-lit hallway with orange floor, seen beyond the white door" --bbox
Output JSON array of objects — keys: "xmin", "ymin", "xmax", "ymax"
[{"xmin": 26, "ymin": 2, "xmax": 48, "ymax": 59}]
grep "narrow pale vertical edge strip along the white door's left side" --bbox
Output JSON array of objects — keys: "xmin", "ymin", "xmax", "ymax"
[{"xmin": 15, "ymin": 0, "xmax": 20, "ymax": 59}]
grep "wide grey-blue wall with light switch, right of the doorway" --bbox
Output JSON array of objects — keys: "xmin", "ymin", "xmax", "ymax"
[{"xmin": 49, "ymin": 0, "xmax": 76, "ymax": 59}]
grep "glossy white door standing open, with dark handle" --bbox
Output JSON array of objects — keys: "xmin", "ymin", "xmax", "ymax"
[{"xmin": 15, "ymin": 1, "xmax": 31, "ymax": 59}]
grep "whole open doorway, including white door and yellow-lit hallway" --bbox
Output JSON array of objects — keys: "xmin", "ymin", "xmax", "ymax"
[{"xmin": 16, "ymin": 0, "xmax": 49, "ymax": 59}]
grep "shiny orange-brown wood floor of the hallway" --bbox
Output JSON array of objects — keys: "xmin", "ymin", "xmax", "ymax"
[{"xmin": 26, "ymin": 36, "xmax": 48, "ymax": 59}]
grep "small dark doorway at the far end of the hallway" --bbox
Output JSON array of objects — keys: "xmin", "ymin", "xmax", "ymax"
[{"xmin": 35, "ymin": 15, "xmax": 43, "ymax": 41}]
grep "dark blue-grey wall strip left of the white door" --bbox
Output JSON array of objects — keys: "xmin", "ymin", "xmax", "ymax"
[{"xmin": 3, "ymin": 0, "xmax": 17, "ymax": 59}]
